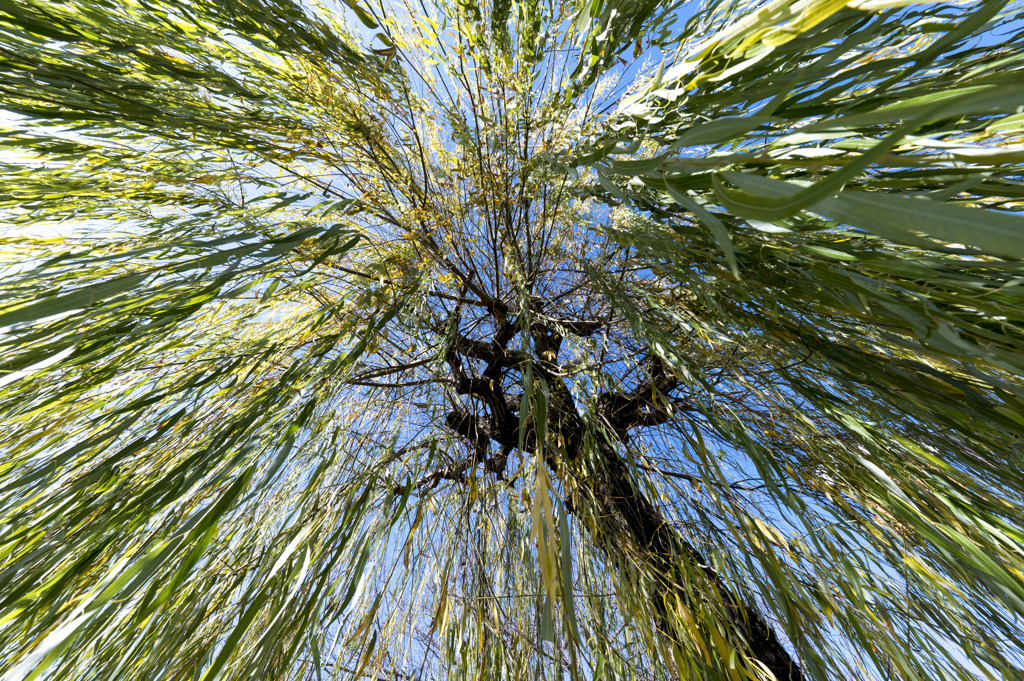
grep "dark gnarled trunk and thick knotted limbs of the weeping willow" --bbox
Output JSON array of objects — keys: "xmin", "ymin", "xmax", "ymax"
[{"xmin": 417, "ymin": 301, "xmax": 803, "ymax": 681}]
